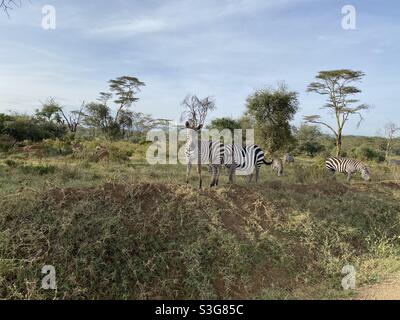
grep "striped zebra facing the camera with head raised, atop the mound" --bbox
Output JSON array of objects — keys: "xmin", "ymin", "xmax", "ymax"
[{"xmin": 185, "ymin": 122, "xmax": 224, "ymax": 188}]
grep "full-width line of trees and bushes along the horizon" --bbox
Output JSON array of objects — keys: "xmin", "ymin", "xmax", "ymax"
[{"xmin": 0, "ymin": 69, "xmax": 400, "ymax": 161}]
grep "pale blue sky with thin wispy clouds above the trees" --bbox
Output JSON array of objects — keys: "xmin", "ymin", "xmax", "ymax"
[{"xmin": 0, "ymin": 0, "xmax": 400, "ymax": 135}]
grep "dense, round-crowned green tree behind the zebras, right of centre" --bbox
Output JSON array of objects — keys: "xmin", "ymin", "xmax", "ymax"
[{"xmin": 246, "ymin": 83, "xmax": 299, "ymax": 153}]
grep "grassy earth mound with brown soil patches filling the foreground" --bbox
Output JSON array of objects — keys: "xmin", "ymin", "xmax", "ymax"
[{"xmin": 0, "ymin": 181, "xmax": 400, "ymax": 299}]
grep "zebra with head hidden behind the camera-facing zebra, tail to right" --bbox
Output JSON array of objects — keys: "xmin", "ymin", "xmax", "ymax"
[{"xmin": 224, "ymin": 144, "xmax": 272, "ymax": 183}]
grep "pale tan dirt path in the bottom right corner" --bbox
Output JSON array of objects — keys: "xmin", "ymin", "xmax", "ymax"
[{"xmin": 356, "ymin": 276, "xmax": 400, "ymax": 300}]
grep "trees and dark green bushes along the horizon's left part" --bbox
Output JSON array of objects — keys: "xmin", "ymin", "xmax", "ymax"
[{"xmin": 0, "ymin": 76, "xmax": 169, "ymax": 149}]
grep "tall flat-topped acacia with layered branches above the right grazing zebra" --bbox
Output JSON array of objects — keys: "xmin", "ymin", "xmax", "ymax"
[{"xmin": 304, "ymin": 69, "xmax": 369, "ymax": 156}]
